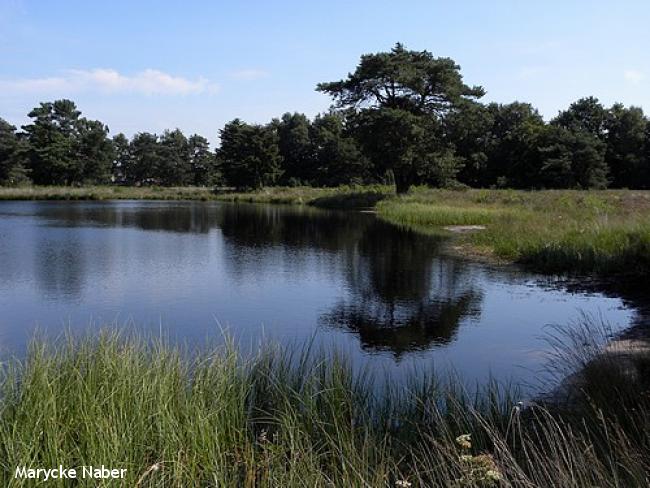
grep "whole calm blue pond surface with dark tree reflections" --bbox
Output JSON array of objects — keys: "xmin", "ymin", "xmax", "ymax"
[{"xmin": 0, "ymin": 202, "xmax": 634, "ymax": 390}]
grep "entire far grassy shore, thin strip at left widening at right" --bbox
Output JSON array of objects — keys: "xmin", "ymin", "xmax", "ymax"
[{"xmin": 0, "ymin": 185, "xmax": 650, "ymax": 281}]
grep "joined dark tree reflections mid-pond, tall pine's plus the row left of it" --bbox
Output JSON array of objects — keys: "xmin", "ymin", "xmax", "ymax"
[{"xmin": 219, "ymin": 206, "xmax": 482, "ymax": 357}]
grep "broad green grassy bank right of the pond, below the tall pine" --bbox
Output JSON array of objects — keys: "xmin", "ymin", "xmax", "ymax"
[{"xmin": 378, "ymin": 190, "xmax": 650, "ymax": 275}]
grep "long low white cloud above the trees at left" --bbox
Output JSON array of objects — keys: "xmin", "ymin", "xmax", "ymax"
[{"xmin": 0, "ymin": 68, "xmax": 218, "ymax": 95}]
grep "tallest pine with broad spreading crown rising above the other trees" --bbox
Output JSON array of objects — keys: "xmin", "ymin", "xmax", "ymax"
[{"xmin": 317, "ymin": 43, "xmax": 485, "ymax": 193}]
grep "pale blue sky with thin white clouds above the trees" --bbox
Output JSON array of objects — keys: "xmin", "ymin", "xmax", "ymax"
[{"xmin": 0, "ymin": 0, "xmax": 650, "ymax": 142}]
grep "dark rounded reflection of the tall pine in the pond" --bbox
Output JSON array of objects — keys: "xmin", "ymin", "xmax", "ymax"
[{"xmin": 319, "ymin": 221, "xmax": 481, "ymax": 357}]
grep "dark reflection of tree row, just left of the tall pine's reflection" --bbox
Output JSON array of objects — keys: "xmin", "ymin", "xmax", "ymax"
[{"xmin": 219, "ymin": 206, "xmax": 373, "ymax": 286}]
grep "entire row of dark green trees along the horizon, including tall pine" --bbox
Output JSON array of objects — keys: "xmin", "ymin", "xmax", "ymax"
[{"xmin": 0, "ymin": 44, "xmax": 650, "ymax": 193}]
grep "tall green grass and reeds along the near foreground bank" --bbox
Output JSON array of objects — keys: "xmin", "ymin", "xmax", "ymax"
[{"xmin": 0, "ymin": 332, "xmax": 650, "ymax": 487}]
